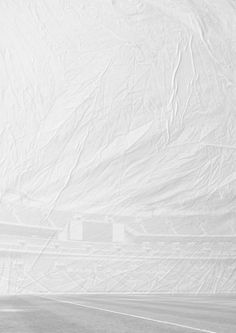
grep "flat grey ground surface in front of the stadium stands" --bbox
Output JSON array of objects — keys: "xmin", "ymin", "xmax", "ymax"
[{"xmin": 0, "ymin": 295, "xmax": 236, "ymax": 333}]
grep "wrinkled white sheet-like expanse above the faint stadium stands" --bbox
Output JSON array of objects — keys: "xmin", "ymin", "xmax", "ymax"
[{"xmin": 0, "ymin": 0, "xmax": 236, "ymax": 222}]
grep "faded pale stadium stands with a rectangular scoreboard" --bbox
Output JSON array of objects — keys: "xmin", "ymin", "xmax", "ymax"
[{"xmin": 0, "ymin": 209, "xmax": 236, "ymax": 294}]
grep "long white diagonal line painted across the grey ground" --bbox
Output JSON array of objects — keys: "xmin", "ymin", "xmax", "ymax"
[{"xmin": 40, "ymin": 296, "xmax": 217, "ymax": 333}]
